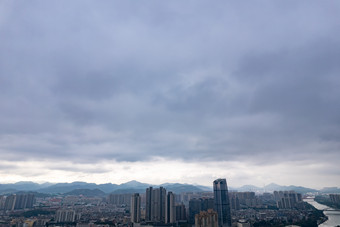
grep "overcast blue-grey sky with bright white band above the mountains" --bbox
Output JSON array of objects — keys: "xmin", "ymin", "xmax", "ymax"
[{"xmin": 0, "ymin": 0, "xmax": 340, "ymax": 188}]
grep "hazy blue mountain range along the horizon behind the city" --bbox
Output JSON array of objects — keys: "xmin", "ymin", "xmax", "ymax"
[{"xmin": 0, "ymin": 180, "xmax": 328, "ymax": 195}]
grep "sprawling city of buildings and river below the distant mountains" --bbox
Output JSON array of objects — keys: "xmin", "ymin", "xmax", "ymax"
[{"xmin": 0, "ymin": 178, "xmax": 340, "ymax": 227}]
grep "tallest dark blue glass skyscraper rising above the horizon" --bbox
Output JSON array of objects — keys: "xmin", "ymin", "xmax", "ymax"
[{"xmin": 213, "ymin": 179, "xmax": 231, "ymax": 227}]
